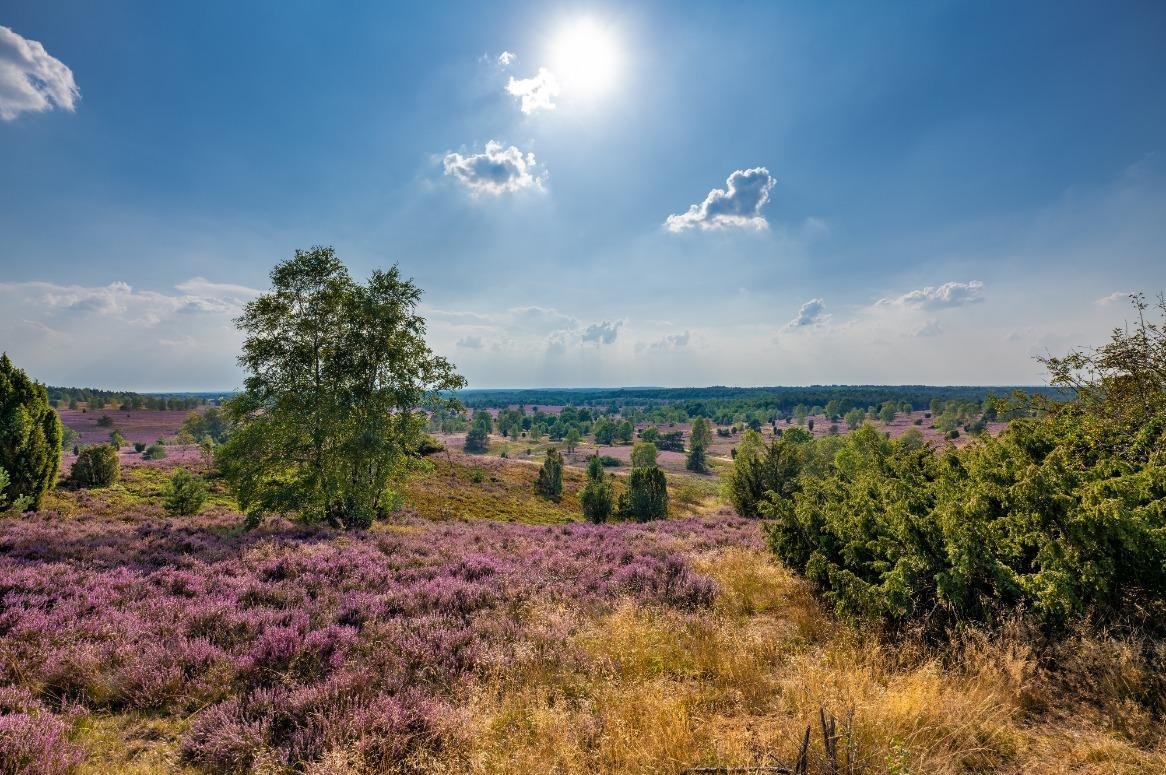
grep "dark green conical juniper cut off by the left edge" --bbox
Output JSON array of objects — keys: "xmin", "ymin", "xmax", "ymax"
[{"xmin": 0, "ymin": 353, "xmax": 62, "ymax": 510}]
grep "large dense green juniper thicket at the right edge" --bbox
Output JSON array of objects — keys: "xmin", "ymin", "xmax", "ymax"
[{"xmin": 769, "ymin": 293, "xmax": 1166, "ymax": 634}]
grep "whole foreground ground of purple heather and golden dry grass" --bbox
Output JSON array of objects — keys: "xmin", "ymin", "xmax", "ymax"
[{"xmin": 0, "ymin": 456, "xmax": 1166, "ymax": 774}]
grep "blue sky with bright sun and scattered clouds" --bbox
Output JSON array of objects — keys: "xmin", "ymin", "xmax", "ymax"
[{"xmin": 0, "ymin": 0, "xmax": 1166, "ymax": 390}]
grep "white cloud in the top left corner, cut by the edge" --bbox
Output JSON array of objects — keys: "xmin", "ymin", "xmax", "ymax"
[{"xmin": 0, "ymin": 27, "xmax": 80, "ymax": 121}]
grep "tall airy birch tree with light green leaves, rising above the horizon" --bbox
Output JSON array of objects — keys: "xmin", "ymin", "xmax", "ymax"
[{"xmin": 217, "ymin": 247, "xmax": 465, "ymax": 528}]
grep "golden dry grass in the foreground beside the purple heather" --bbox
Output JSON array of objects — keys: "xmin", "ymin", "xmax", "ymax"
[{"xmin": 443, "ymin": 550, "xmax": 1166, "ymax": 774}]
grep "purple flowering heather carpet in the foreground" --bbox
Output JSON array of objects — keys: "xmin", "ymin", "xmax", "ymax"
[{"xmin": 0, "ymin": 501, "xmax": 760, "ymax": 773}]
